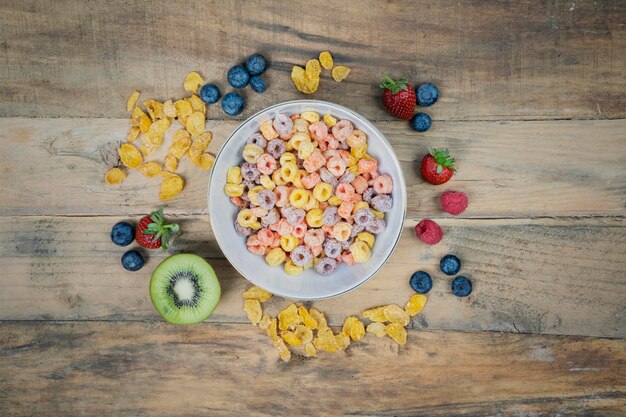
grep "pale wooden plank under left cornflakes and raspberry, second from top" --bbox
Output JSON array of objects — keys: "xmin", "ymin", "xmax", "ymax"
[{"xmin": 0, "ymin": 118, "xmax": 626, "ymax": 218}]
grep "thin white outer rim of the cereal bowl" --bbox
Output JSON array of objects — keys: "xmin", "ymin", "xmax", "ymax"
[{"xmin": 207, "ymin": 99, "xmax": 407, "ymax": 301}]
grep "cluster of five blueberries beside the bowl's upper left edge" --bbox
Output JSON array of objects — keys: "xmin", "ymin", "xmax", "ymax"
[{"xmin": 200, "ymin": 54, "xmax": 267, "ymax": 116}]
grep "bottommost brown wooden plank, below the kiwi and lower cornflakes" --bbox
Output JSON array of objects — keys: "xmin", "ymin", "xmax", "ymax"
[{"xmin": 0, "ymin": 322, "xmax": 626, "ymax": 417}]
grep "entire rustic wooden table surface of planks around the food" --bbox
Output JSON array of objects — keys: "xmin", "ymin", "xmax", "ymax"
[{"xmin": 0, "ymin": 0, "xmax": 626, "ymax": 417}]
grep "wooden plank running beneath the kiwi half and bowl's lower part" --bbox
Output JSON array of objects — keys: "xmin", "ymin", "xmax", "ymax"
[{"xmin": 0, "ymin": 216, "xmax": 626, "ymax": 338}]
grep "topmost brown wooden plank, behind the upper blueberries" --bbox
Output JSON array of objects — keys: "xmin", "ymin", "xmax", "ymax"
[{"xmin": 0, "ymin": 0, "xmax": 626, "ymax": 120}]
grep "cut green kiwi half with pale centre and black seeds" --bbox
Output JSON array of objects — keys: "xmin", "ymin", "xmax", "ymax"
[{"xmin": 150, "ymin": 253, "xmax": 222, "ymax": 324}]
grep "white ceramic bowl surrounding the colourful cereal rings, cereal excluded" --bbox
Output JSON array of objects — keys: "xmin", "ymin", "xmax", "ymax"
[{"xmin": 208, "ymin": 100, "xmax": 406, "ymax": 300}]
